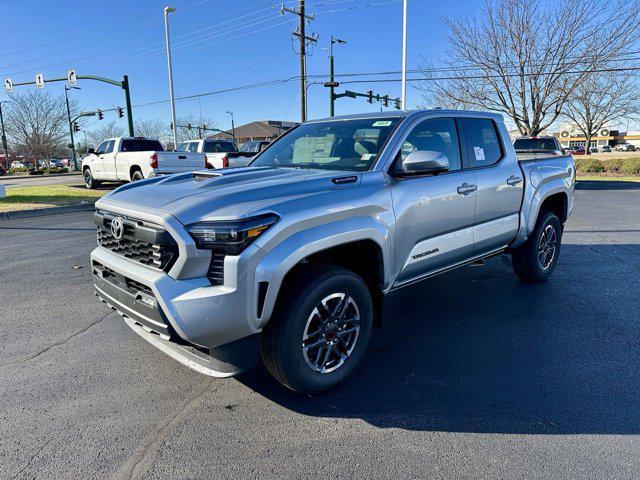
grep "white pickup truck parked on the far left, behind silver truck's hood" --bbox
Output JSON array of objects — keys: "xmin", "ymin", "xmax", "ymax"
[{"xmin": 82, "ymin": 137, "xmax": 205, "ymax": 188}]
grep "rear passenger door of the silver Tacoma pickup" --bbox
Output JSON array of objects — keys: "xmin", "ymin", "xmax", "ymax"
[{"xmin": 462, "ymin": 117, "xmax": 524, "ymax": 255}]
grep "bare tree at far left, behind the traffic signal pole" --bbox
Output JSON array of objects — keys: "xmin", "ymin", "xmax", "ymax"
[{"xmin": 5, "ymin": 90, "xmax": 76, "ymax": 160}]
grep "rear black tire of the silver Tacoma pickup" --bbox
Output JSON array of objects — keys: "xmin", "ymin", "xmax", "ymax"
[{"xmin": 511, "ymin": 211, "xmax": 562, "ymax": 283}]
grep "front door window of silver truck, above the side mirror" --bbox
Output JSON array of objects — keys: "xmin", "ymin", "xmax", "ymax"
[{"xmin": 400, "ymin": 118, "xmax": 462, "ymax": 171}]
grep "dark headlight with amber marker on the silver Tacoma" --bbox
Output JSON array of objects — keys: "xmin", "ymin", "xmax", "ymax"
[{"xmin": 187, "ymin": 214, "xmax": 280, "ymax": 255}]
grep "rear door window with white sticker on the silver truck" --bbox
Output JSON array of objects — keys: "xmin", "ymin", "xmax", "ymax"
[{"xmin": 462, "ymin": 118, "xmax": 502, "ymax": 168}]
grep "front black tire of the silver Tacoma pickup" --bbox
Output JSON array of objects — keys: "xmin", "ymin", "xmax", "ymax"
[{"xmin": 262, "ymin": 266, "xmax": 374, "ymax": 395}]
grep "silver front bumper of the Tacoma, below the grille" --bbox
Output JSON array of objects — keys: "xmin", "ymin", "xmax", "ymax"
[{"xmin": 91, "ymin": 247, "xmax": 259, "ymax": 377}]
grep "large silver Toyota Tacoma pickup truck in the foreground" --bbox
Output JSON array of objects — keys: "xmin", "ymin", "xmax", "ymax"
[{"xmin": 91, "ymin": 110, "xmax": 575, "ymax": 394}]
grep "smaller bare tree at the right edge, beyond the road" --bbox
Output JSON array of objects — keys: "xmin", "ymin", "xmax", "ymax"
[{"xmin": 563, "ymin": 72, "xmax": 640, "ymax": 155}]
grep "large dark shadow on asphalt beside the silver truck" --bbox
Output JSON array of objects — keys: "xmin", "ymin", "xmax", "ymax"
[{"xmin": 238, "ymin": 244, "xmax": 640, "ymax": 434}]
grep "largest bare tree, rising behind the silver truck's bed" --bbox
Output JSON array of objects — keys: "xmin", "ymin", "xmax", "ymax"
[{"xmin": 421, "ymin": 0, "xmax": 640, "ymax": 135}]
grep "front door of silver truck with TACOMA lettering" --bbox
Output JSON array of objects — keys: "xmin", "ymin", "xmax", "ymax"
[{"xmin": 390, "ymin": 117, "xmax": 476, "ymax": 285}]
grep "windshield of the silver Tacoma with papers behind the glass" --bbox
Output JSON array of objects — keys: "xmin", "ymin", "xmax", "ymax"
[{"xmin": 251, "ymin": 117, "xmax": 402, "ymax": 171}]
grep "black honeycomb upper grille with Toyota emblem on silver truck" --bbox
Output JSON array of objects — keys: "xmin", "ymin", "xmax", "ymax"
[{"xmin": 95, "ymin": 212, "xmax": 178, "ymax": 271}]
